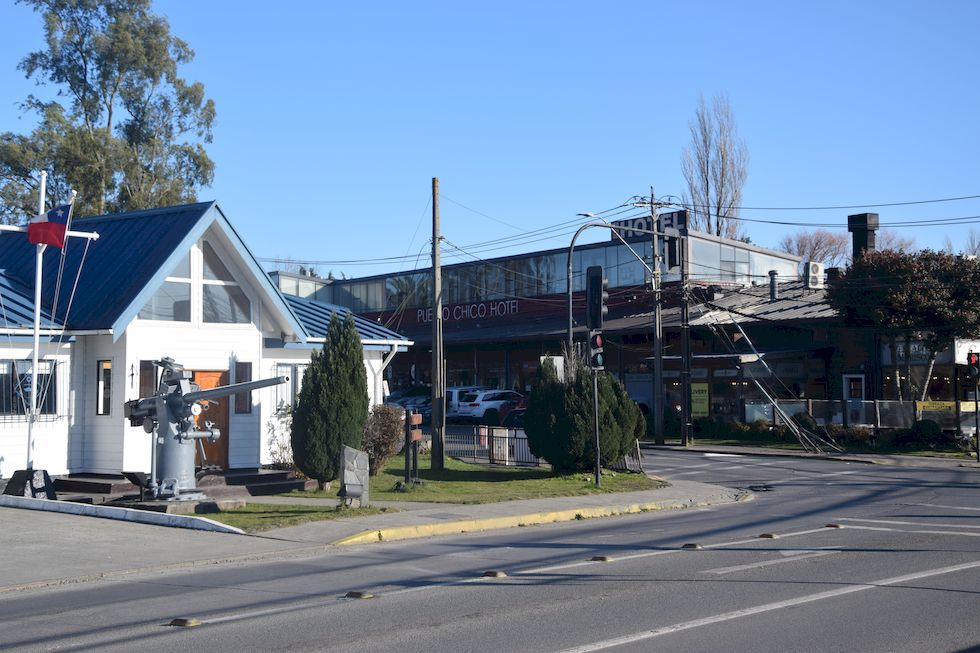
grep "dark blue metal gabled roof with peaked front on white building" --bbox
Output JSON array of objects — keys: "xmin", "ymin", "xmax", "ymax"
[{"xmin": 0, "ymin": 202, "xmax": 305, "ymax": 340}]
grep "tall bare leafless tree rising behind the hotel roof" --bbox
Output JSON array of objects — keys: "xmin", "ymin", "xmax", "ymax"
[{"xmin": 681, "ymin": 94, "xmax": 749, "ymax": 239}]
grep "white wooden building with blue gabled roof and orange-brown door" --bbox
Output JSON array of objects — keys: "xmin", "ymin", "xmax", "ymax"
[{"xmin": 0, "ymin": 202, "xmax": 412, "ymax": 478}]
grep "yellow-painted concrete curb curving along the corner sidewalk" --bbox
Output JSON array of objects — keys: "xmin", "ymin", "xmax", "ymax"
[{"xmin": 331, "ymin": 493, "xmax": 755, "ymax": 546}]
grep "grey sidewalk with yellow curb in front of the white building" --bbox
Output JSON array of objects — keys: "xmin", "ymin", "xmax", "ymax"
[{"xmin": 0, "ymin": 480, "xmax": 751, "ymax": 594}]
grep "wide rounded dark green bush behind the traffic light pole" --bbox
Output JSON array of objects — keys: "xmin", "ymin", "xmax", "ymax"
[{"xmin": 524, "ymin": 362, "xmax": 646, "ymax": 472}]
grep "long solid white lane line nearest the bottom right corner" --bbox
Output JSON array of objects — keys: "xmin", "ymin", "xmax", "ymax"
[{"xmin": 561, "ymin": 560, "xmax": 980, "ymax": 653}]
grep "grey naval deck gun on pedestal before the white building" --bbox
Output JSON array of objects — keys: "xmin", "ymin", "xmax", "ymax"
[{"xmin": 125, "ymin": 358, "xmax": 289, "ymax": 501}]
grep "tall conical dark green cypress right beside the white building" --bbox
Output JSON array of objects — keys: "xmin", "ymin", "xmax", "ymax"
[{"xmin": 291, "ymin": 313, "xmax": 368, "ymax": 488}]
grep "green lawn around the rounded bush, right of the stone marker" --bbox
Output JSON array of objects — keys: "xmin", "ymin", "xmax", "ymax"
[{"xmin": 284, "ymin": 455, "xmax": 664, "ymax": 503}]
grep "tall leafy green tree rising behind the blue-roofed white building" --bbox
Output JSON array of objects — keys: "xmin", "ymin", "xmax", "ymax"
[{"xmin": 0, "ymin": 0, "xmax": 215, "ymax": 222}]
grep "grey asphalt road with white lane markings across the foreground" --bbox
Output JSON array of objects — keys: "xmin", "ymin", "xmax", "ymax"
[{"xmin": 0, "ymin": 451, "xmax": 980, "ymax": 653}]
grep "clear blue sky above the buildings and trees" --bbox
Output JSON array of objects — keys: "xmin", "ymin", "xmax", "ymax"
[{"xmin": 0, "ymin": 0, "xmax": 980, "ymax": 277}]
